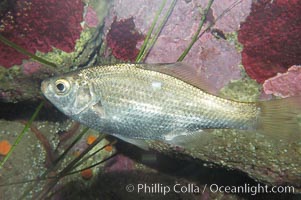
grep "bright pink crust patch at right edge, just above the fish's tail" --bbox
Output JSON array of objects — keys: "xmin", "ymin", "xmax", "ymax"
[{"xmin": 263, "ymin": 65, "xmax": 301, "ymax": 98}]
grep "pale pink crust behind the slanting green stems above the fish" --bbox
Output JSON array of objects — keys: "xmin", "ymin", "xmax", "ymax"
[{"xmin": 105, "ymin": 0, "xmax": 251, "ymax": 92}]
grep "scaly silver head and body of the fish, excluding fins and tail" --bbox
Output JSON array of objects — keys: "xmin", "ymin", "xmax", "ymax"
[{"xmin": 42, "ymin": 64, "xmax": 268, "ymax": 144}]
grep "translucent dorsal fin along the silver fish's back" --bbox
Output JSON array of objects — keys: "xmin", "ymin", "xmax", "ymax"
[{"xmin": 138, "ymin": 62, "xmax": 215, "ymax": 94}]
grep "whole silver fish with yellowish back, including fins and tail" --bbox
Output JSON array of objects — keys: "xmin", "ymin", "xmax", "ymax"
[{"xmin": 41, "ymin": 63, "xmax": 301, "ymax": 149}]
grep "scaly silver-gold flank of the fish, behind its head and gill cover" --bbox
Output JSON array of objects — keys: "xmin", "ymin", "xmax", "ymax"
[{"xmin": 75, "ymin": 65, "xmax": 255, "ymax": 138}]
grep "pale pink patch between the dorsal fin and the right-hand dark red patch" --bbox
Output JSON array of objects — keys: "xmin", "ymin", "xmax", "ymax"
[{"xmin": 179, "ymin": 33, "xmax": 241, "ymax": 94}]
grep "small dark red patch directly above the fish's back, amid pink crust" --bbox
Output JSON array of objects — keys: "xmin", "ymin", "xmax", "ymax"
[{"xmin": 107, "ymin": 18, "xmax": 144, "ymax": 61}]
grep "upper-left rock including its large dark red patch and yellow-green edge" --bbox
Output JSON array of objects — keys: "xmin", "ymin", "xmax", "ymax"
[{"xmin": 0, "ymin": 1, "xmax": 108, "ymax": 103}]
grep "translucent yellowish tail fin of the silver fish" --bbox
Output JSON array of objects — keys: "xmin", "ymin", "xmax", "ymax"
[{"xmin": 257, "ymin": 96, "xmax": 301, "ymax": 141}]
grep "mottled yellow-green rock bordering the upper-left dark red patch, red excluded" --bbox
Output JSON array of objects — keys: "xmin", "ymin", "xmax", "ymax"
[{"xmin": 0, "ymin": 0, "xmax": 109, "ymax": 103}]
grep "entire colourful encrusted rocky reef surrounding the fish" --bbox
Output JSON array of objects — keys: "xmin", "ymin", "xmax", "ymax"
[{"xmin": 0, "ymin": 0, "xmax": 301, "ymax": 199}]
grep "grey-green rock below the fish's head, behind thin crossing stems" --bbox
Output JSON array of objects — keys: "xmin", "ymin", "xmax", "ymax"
[{"xmin": 0, "ymin": 120, "xmax": 115, "ymax": 200}]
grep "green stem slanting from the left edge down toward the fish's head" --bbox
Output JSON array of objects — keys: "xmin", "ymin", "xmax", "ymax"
[{"xmin": 0, "ymin": 34, "xmax": 57, "ymax": 67}]
